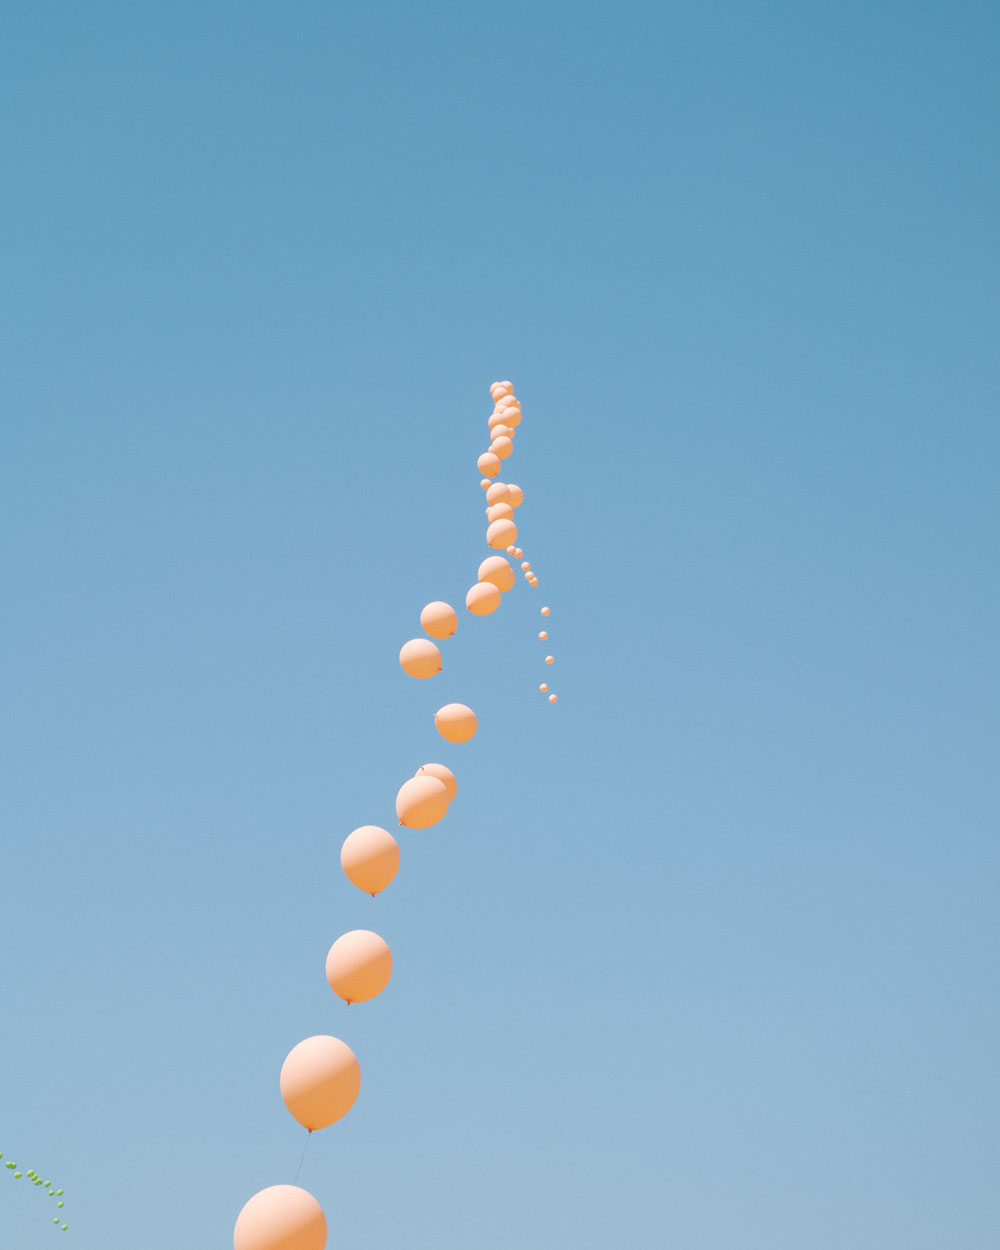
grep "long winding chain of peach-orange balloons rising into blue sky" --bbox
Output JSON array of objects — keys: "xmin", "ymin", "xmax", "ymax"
[{"xmin": 233, "ymin": 381, "xmax": 556, "ymax": 1250}]
